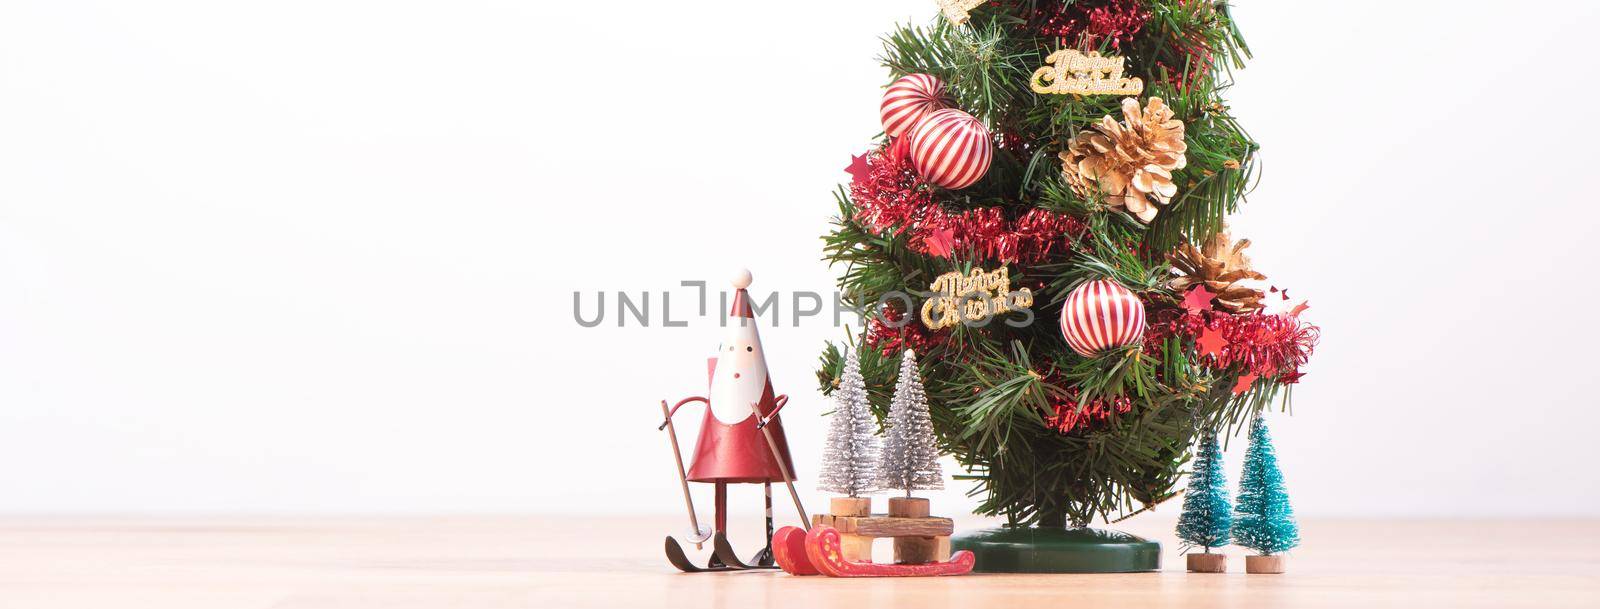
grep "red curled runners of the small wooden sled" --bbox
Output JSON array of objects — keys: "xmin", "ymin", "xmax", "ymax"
[{"xmin": 773, "ymin": 524, "xmax": 976, "ymax": 577}]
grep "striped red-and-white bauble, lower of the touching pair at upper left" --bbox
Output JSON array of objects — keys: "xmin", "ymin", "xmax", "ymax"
[{"xmin": 907, "ymin": 109, "xmax": 994, "ymax": 189}]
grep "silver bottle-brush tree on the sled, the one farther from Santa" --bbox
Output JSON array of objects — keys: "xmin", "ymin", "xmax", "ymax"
[{"xmin": 878, "ymin": 348, "xmax": 944, "ymax": 497}]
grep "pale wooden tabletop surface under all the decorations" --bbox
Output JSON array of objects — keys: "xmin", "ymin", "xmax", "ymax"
[{"xmin": 0, "ymin": 516, "xmax": 1600, "ymax": 609}]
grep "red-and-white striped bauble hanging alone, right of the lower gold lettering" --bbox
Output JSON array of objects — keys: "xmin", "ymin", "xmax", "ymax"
[{"xmin": 1061, "ymin": 280, "xmax": 1144, "ymax": 356}]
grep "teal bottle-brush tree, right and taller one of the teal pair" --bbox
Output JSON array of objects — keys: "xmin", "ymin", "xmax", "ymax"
[{"xmin": 1234, "ymin": 417, "xmax": 1299, "ymax": 555}]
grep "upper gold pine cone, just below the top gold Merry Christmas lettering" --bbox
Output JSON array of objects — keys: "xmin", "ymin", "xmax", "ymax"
[{"xmin": 1061, "ymin": 98, "xmax": 1189, "ymax": 222}]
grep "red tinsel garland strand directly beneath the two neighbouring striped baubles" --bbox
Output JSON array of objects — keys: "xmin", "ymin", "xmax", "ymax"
[{"xmin": 850, "ymin": 145, "xmax": 1088, "ymax": 262}]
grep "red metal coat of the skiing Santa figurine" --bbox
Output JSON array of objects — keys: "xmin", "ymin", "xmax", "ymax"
[{"xmin": 690, "ymin": 358, "xmax": 795, "ymax": 483}]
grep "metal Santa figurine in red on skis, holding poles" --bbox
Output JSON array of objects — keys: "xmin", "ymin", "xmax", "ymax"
[{"xmin": 661, "ymin": 270, "xmax": 805, "ymax": 571}]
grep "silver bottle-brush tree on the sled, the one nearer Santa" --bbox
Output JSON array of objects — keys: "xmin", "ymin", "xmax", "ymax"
[{"xmin": 818, "ymin": 350, "xmax": 878, "ymax": 497}]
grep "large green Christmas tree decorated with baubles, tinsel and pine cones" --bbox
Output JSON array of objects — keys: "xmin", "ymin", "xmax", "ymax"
[{"xmin": 818, "ymin": 0, "xmax": 1317, "ymax": 526}]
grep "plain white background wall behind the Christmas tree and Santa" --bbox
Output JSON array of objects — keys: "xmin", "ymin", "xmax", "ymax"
[{"xmin": 0, "ymin": 0, "xmax": 1600, "ymax": 516}]
